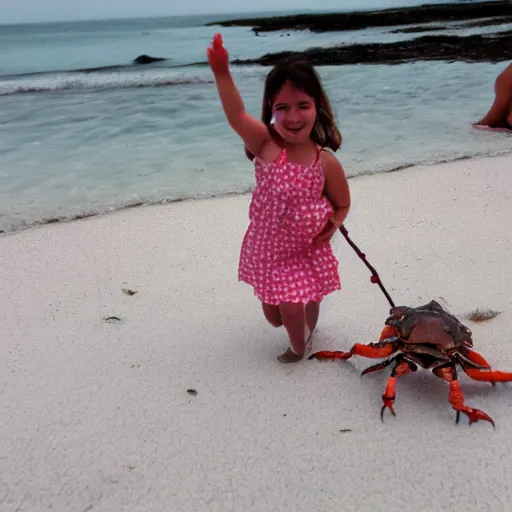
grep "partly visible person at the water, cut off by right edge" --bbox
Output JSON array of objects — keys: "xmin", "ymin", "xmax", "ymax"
[{"xmin": 473, "ymin": 64, "xmax": 512, "ymax": 133}]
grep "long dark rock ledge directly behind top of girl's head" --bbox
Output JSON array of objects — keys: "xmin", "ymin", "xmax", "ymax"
[{"xmin": 233, "ymin": 30, "xmax": 512, "ymax": 66}]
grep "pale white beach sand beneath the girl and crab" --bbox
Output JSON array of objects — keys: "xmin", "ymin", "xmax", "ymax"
[{"xmin": 0, "ymin": 156, "xmax": 512, "ymax": 512}]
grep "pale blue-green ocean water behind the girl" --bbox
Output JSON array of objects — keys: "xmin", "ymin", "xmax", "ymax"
[{"xmin": 0, "ymin": 13, "xmax": 512, "ymax": 233}]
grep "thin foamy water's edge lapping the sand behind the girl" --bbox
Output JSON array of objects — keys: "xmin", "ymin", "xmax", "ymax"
[{"xmin": 0, "ymin": 149, "xmax": 512, "ymax": 236}]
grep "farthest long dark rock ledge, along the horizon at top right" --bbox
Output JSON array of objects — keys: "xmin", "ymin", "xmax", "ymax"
[{"xmin": 207, "ymin": 0, "xmax": 512, "ymax": 33}]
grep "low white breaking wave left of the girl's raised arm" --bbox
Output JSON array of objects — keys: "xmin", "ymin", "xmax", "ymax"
[{"xmin": 0, "ymin": 70, "xmax": 213, "ymax": 96}]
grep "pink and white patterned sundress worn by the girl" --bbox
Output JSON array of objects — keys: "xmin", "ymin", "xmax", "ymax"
[{"xmin": 238, "ymin": 146, "xmax": 341, "ymax": 305}]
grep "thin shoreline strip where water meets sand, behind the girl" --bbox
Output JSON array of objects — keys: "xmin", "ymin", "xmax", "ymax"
[{"xmin": 0, "ymin": 149, "xmax": 512, "ymax": 237}]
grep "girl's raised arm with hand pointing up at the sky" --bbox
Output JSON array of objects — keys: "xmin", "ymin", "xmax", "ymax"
[{"xmin": 207, "ymin": 34, "xmax": 270, "ymax": 155}]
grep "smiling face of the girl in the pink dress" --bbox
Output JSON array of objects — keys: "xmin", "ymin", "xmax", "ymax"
[{"xmin": 272, "ymin": 82, "xmax": 316, "ymax": 144}]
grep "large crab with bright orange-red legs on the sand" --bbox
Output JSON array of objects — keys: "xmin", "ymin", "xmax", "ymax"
[{"xmin": 309, "ymin": 300, "xmax": 512, "ymax": 427}]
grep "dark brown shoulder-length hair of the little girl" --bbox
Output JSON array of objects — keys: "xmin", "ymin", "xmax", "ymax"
[{"xmin": 245, "ymin": 58, "xmax": 342, "ymax": 160}]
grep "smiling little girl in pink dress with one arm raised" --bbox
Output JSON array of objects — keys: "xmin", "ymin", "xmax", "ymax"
[{"xmin": 207, "ymin": 34, "xmax": 350, "ymax": 363}]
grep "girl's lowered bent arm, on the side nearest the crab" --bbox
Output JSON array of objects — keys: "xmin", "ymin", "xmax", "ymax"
[{"xmin": 315, "ymin": 151, "xmax": 351, "ymax": 245}]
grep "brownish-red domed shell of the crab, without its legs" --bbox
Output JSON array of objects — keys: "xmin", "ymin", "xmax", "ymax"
[{"xmin": 381, "ymin": 300, "xmax": 473, "ymax": 353}]
